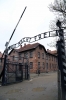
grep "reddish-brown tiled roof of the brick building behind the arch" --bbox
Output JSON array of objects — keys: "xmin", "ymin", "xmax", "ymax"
[{"xmin": 9, "ymin": 43, "xmax": 57, "ymax": 56}]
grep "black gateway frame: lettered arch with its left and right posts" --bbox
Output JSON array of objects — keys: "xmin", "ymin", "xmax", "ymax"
[{"xmin": 2, "ymin": 20, "xmax": 66, "ymax": 100}]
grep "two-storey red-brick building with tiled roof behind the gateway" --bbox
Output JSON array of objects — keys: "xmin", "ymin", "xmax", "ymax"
[{"xmin": 9, "ymin": 43, "xmax": 58, "ymax": 73}]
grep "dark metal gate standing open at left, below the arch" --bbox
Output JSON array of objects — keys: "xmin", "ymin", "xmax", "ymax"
[{"xmin": 2, "ymin": 56, "xmax": 29, "ymax": 85}]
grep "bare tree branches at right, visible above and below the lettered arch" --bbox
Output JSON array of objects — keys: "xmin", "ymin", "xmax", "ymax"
[{"xmin": 48, "ymin": 0, "xmax": 66, "ymax": 47}]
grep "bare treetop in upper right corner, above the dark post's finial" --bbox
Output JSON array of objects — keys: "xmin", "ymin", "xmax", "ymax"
[{"xmin": 49, "ymin": 0, "xmax": 66, "ymax": 26}]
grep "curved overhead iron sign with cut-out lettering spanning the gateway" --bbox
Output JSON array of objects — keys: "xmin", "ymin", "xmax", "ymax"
[{"xmin": 8, "ymin": 30, "xmax": 58, "ymax": 50}]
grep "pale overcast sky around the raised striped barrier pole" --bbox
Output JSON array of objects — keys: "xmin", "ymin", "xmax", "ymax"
[{"xmin": 0, "ymin": 0, "xmax": 55, "ymax": 52}]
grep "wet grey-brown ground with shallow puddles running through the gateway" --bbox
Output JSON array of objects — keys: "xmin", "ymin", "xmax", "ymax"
[{"xmin": 0, "ymin": 72, "xmax": 58, "ymax": 100}]
